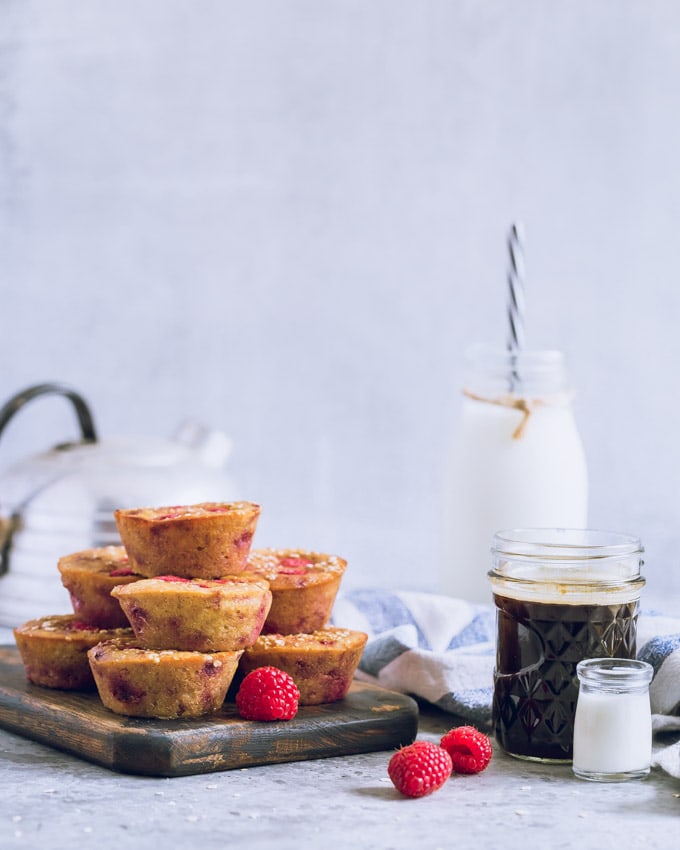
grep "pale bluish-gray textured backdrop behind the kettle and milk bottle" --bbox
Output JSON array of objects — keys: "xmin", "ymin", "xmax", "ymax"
[{"xmin": 0, "ymin": 0, "xmax": 680, "ymax": 608}]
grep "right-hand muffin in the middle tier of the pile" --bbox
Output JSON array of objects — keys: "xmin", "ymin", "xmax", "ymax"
[{"xmin": 243, "ymin": 549, "xmax": 347, "ymax": 635}]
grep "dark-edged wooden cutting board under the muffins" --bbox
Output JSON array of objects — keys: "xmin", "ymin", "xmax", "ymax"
[{"xmin": 0, "ymin": 646, "xmax": 418, "ymax": 776}]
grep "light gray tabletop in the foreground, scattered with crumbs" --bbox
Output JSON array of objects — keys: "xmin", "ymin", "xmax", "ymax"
[{"xmin": 0, "ymin": 629, "xmax": 680, "ymax": 850}]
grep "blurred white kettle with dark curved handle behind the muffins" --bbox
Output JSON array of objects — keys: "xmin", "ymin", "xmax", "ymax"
[{"xmin": 0, "ymin": 383, "xmax": 238, "ymax": 627}]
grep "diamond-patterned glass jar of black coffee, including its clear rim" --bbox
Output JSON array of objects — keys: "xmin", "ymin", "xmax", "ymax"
[{"xmin": 489, "ymin": 528, "xmax": 645, "ymax": 762}]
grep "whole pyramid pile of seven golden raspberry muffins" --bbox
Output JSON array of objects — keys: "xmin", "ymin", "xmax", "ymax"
[{"xmin": 14, "ymin": 502, "xmax": 367, "ymax": 718}]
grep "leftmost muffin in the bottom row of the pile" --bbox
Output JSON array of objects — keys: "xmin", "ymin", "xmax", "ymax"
[{"xmin": 14, "ymin": 614, "xmax": 132, "ymax": 691}]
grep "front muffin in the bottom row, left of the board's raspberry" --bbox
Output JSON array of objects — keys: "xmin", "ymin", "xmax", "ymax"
[{"xmin": 88, "ymin": 638, "xmax": 242, "ymax": 719}]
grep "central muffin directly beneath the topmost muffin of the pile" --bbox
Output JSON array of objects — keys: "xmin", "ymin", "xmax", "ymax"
[{"xmin": 112, "ymin": 576, "xmax": 272, "ymax": 652}]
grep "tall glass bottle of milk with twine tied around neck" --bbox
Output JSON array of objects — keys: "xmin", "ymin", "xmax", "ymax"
[{"xmin": 442, "ymin": 347, "xmax": 588, "ymax": 603}]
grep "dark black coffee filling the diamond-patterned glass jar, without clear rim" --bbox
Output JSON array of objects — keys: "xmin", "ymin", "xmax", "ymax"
[{"xmin": 493, "ymin": 594, "xmax": 639, "ymax": 761}]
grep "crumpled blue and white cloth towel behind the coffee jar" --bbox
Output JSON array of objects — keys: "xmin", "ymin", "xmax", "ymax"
[{"xmin": 333, "ymin": 589, "xmax": 680, "ymax": 777}]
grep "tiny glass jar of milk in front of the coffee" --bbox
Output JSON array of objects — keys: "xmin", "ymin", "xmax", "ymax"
[{"xmin": 572, "ymin": 658, "xmax": 654, "ymax": 782}]
